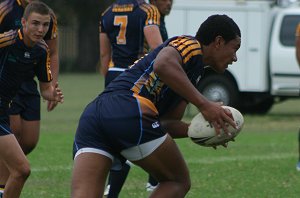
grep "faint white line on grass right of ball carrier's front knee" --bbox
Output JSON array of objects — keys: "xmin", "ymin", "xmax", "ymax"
[{"xmin": 186, "ymin": 153, "xmax": 297, "ymax": 164}]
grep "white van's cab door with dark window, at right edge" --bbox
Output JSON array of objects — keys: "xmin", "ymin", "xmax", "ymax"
[{"xmin": 269, "ymin": 8, "xmax": 300, "ymax": 96}]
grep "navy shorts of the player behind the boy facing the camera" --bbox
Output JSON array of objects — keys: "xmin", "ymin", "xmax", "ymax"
[{"xmin": 9, "ymin": 80, "xmax": 41, "ymax": 121}]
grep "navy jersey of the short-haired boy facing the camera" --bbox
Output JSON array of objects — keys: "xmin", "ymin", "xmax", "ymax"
[{"xmin": 0, "ymin": 29, "xmax": 52, "ymax": 102}]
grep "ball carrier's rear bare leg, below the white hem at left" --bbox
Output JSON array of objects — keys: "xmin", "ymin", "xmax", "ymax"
[{"xmin": 71, "ymin": 153, "xmax": 112, "ymax": 198}]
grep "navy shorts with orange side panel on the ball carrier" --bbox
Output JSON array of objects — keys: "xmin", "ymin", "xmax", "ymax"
[{"xmin": 73, "ymin": 93, "xmax": 166, "ymax": 159}]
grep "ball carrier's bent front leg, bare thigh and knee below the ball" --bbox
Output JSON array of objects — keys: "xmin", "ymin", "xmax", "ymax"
[{"xmin": 122, "ymin": 135, "xmax": 191, "ymax": 198}]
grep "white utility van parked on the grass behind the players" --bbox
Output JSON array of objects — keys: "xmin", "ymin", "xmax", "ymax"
[{"xmin": 166, "ymin": 0, "xmax": 300, "ymax": 113}]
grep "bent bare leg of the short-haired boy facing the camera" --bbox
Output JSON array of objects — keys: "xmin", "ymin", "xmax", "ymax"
[{"xmin": 0, "ymin": 134, "xmax": 30, "ymax": 198}]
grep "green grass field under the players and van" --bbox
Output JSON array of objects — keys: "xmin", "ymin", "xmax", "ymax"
[{"xmin": 21, "ymin": 74, "xmax": 300, "ymax": 198}]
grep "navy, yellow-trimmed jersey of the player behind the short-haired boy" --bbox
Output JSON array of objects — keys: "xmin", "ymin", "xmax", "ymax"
[{"xmin": 0, "ymin": 0, "xmax": 57, "ymax": 40}]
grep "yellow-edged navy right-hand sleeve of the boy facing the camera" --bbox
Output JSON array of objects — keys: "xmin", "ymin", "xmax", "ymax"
[{"xmin": 35, "ymin": 45, "xmax": 52, "ymax": 82}]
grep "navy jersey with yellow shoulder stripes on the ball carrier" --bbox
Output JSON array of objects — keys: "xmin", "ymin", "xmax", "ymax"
[{"xmin": 104, "ymin": 36, "xmax": 204, "ymax": 114}]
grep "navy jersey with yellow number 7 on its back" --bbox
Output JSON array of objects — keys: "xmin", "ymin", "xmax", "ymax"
[{"xmin": 99, "ymin": 0, "xmax": 160, "ymax": 68}]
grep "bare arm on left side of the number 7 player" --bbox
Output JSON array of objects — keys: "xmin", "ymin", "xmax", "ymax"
[{"xmin": 99, "ymin": 33, "xmax": 111, "ymax": 76}]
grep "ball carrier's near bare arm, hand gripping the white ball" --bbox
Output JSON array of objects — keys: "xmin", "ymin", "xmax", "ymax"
[{"xmin": 154, "ymin": 47, "xmax": 236, "ymax": 134}]
